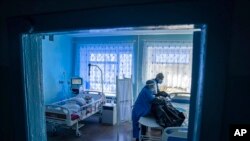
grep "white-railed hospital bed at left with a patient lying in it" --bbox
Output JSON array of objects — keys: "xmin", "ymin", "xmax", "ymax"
[{"xmin": 45, "ymin": 91, "xmax": 105, "ymax": 136}]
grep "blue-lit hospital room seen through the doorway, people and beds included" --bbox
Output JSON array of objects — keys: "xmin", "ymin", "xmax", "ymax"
[{"xmin": 26, "ymin": 25, "xmax": 196, "ymax": 141}]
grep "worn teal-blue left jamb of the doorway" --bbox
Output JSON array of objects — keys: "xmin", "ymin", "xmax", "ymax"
[{"xmin": 22, "ymin": 34, "xmax": 47, "ymax": 141}]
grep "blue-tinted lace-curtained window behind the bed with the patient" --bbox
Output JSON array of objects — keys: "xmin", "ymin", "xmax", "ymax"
[{"xmin": 77, "ymin": 42, "xmax": 133, "ymax": 94}]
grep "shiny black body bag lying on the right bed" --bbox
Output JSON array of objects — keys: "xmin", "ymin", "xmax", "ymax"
[{"xmin": 151, "ymin": 100, "xmax": 185, "ymax": 128}]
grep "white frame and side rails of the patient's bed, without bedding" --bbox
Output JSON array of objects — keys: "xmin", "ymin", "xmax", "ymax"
[{"xmin": 45, "ymin": 91, "xmax": 105, "ymax": 136}]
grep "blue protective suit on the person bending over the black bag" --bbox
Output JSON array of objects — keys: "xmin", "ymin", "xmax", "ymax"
[{"xmin": 132, "ymin": 86, "xmax": 155, "ymax": 138}]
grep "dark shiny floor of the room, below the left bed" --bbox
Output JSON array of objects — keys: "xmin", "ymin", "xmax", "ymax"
[{"xmin": 47, "ymin": 116, "xmax": 133, "ymax": 141}]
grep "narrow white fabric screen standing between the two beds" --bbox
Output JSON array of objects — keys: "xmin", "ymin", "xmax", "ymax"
[{"xmin": 116, "ymin": 78, "xmax": 133, "ymax": 123}]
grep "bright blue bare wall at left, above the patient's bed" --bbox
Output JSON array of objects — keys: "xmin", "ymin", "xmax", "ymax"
[{"xmin": 42, "ymin": 36, "xmax": 73, "ymax": 104}]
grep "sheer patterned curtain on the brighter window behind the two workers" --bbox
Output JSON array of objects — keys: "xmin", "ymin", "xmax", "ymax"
[{"xmin": 142, "ymin": 40, "xmax": 192, "ymax": 92}]
